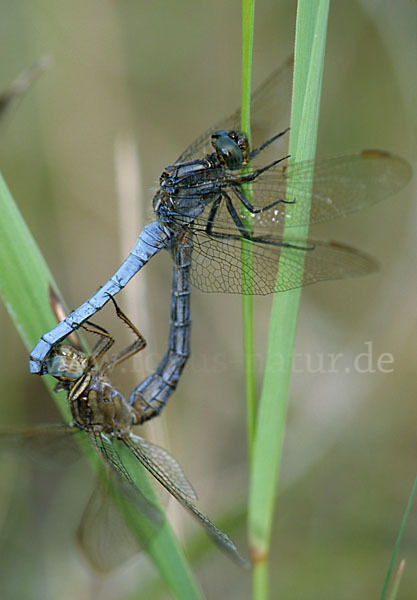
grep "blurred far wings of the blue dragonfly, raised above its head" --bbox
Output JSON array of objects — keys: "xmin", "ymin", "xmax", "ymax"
[{"xmin": 176, "ymin": 56, "xmax": 294, "ymax": 163}]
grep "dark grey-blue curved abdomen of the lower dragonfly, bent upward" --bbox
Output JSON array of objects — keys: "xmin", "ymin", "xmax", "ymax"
[{"xmin": 129, "ymin": 243, "xmax": 192, "ymax": 423}]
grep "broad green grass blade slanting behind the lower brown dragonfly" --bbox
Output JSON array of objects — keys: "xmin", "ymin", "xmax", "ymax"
[{"xmin": 0, "ymin": 170, "xmax": 203, "ymax": 600}]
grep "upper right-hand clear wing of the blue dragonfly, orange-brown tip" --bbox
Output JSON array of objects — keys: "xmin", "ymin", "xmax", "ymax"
[{"xmin": 239, "ymin": 150, "xmax": 411, "ymax": 232}]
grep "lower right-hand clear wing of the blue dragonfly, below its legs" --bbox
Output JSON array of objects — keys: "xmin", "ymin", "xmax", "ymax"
[{"xmin": 182, "ymin": 232, "xmax": 378, "ymax": 295}]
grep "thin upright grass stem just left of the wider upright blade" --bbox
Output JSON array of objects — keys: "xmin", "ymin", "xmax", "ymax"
[{"xmin": 241, "ymin": 0, "xmax": 256, "ymax": 457}]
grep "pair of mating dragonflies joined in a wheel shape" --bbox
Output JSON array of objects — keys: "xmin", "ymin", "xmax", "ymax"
[{"xmin": 30, "ymin": 54, "xmax": 411, "ymax": 560}]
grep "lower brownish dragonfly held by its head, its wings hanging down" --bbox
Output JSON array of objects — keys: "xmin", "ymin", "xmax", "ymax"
[{"xmin": 8, "ymin": 298, "xmax": 249, "ymax": 567}]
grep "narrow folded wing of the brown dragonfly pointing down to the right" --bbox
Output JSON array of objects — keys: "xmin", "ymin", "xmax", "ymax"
[{"xmin": 123, "ymin": 435, "xmax": 248, "ymax": 566}]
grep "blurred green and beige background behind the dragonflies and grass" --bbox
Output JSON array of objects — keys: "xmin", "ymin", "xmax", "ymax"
[{"xmin": 0, "ymin": 0, "xmax": 417, "ymax": 600}]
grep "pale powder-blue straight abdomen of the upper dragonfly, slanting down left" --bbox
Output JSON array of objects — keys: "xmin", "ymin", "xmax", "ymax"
[{"xmin": 30, "ymin": 221, "xmax": 171, "ymax": 375}]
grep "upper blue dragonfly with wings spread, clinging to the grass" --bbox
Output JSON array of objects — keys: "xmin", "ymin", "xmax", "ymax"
[{"xmin": 30, "ymin": 59, "xmax": 411, "ymax": 374}]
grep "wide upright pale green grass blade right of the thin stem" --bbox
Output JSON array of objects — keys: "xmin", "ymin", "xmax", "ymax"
[{"xmin": 245, "ymin": 0, "xmax": 329, "ymax": 600}]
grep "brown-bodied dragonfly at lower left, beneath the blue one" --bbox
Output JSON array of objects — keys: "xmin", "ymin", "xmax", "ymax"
[{"xmin": 6, "ymin": 298, "xmax": 248, "ymax": 571}]
